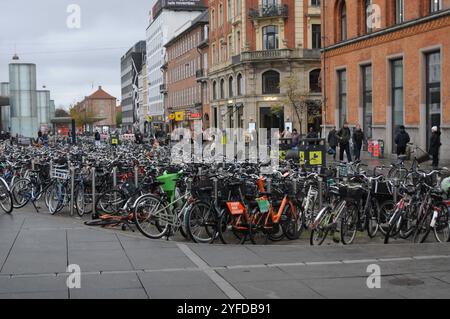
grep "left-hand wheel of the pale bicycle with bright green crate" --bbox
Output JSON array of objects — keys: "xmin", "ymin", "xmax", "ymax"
[{"xmin": 134, "ymin": 194, "xmax": 173, "ymax": 239}]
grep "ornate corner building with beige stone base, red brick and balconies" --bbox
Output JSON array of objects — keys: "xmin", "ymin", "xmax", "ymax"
[{"xmin": 208, "ymin": 0, "xmax": 321, "ymax": 133}]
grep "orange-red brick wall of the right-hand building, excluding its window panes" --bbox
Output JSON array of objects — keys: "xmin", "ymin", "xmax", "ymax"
[{"xmin": 322, "ymin": 0, "xmax": 450, "ymax": 157}]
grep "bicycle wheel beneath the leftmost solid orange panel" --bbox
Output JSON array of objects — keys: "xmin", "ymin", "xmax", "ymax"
[{"xmin": 219, "ymin": 210, "xmax": 248, "ymax": 245}]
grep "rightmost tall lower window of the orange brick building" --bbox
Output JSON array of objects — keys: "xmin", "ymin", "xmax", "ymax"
[{"xmin": 426, "ymin": 51, "xmax": 441, "ymax": 145}]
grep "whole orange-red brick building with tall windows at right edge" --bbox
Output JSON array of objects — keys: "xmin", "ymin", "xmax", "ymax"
[{"xmin": 322, "ymin": 0, "xmax": 450, "ymax": 158}]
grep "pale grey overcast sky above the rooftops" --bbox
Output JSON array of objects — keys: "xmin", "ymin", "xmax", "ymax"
[{"xmin": 0, "ymin": 0, "xmax": 155, "ymax": 108}]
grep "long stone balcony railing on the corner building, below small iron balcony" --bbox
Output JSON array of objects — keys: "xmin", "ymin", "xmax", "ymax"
[{"xmin": 241, "ymin": 49, "xmax": 320, "ymax": 62}]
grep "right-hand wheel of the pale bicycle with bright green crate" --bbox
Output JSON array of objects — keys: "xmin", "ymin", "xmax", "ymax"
[{"xmin": 184, "ymin": 202, "xmax": 217, "ymax": 244}]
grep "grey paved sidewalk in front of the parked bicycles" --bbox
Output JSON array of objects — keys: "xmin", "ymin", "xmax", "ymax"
[{"xmin": 0, "ymin": 210, "xmax": 450, "ymax": 299}]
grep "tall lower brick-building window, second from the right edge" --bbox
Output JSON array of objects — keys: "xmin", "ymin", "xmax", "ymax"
[{"xmin": 391, "ymin": 59, "xmax": 404, "ymax": 145}]
